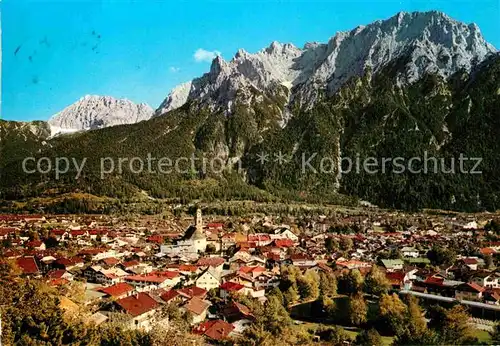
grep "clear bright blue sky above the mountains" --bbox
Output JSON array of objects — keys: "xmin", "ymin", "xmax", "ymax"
[{"xmin": 0, "ymin": 0, "xmax": 500, "ymax": 121}]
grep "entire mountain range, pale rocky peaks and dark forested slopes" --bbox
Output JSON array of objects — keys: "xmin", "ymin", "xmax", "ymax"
[{"xmin": 0, "ymin": 11, "xmax": 500, "ymax": 210}]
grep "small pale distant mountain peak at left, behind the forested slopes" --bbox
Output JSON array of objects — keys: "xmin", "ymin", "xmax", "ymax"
[{"xmin": 49, "ymin": 95, "xmax": 153, "ymax": 134}]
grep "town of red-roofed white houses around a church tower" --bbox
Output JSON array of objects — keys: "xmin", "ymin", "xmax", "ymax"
[{"xmin": 0, "ymin": 210, "xmax": 500, "ymax": 340}]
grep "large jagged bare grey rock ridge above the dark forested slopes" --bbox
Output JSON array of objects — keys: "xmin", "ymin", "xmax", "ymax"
[{"xmin": 156, "ymin": 11, "xmax": 496, "ymax": 115}]
